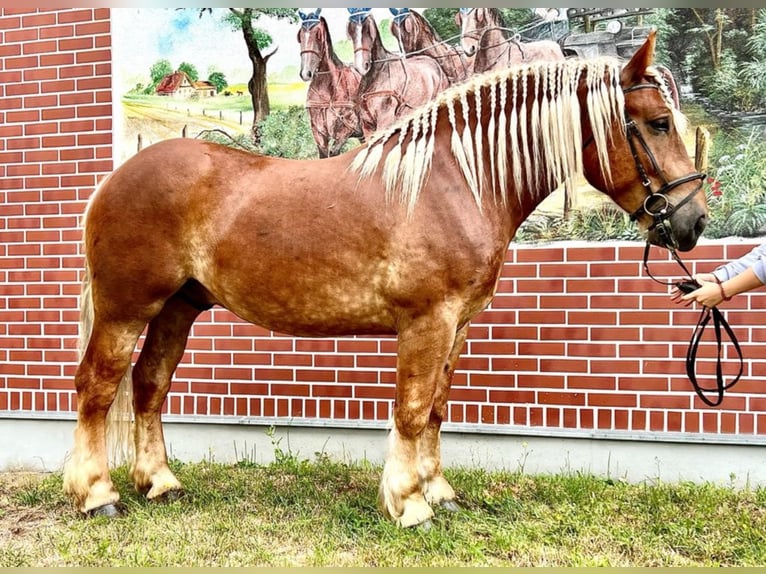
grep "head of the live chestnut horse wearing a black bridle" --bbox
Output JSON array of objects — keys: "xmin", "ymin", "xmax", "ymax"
[{"xmin": 583, "ymin": 32, "xmax": 707, "ymax": 251}]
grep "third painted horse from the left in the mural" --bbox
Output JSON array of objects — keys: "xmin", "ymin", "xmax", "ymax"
[{"xmin": 389, "ymin": 8, "xmax": 473, "ymax": 84}]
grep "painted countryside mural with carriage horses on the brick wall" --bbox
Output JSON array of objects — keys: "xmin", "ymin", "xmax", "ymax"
[{"xmin": 112, "ymin": 8, "xmax": 766, "ymax": 241}]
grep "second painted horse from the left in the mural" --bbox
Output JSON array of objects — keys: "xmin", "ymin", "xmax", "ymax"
[{"xmin": 346, "ymin": 8, "xmax": 449, "ymax": 137}]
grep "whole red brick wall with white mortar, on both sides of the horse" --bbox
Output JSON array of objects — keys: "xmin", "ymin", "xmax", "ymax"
[{"xmin": 0, "ymin": 9, "xmax": 766, "ymax": 435}]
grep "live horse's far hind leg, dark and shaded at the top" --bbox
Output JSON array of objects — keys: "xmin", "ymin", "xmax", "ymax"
[{"xmin": 132, "ymin": 295, "xmax": 201, "ymax": 500}]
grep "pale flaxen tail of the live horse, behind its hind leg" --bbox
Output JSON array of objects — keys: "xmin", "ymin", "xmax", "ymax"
[{"xmin": 77, "ymin": 183, "xmax": 134, "ymax": 466}]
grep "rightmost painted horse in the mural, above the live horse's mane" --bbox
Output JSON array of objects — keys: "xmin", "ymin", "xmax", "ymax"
[{"xmin": 455, "ymin": 8, "xmax": 564, "ymax": 73}]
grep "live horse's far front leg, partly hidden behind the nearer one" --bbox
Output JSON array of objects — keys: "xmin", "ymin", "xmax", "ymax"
[{"xmin": 418, "ymin": 324, "xmax": 468, "ymax": 510}]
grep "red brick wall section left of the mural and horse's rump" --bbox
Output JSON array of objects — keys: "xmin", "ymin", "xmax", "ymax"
[{"xmin": 0, "ymin": 8, "xmax": 113, "ymax": 412}]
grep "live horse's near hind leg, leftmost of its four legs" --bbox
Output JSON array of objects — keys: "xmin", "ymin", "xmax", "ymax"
[{"xmin": 64, "ymin": 318, "xmax": 144, "ymax": 514}]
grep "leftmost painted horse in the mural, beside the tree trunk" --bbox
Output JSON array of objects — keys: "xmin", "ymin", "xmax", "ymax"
[{"xmin": 298, "ymin": 8, "xmax": 363, "ymax": 158}]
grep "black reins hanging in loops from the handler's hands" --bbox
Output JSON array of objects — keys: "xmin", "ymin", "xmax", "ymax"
[{"xmin": 644, "ymin": 241, "xmax": 744, "ymax": 407}]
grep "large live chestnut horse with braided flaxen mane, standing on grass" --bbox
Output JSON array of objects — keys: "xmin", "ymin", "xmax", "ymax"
[{"xmin": 64, "ymin": 34, "xmax": 707, "ymax": 526}]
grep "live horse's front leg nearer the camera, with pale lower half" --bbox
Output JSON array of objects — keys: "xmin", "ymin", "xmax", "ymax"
[{"xmin": 380, "ymin": 314, "xmax": 455, "ymax": 526}]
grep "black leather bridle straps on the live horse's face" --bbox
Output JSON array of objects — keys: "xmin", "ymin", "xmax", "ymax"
[{"xmin": 623, "ymin": 83, "xmax": 707, "ymax": 249}]
